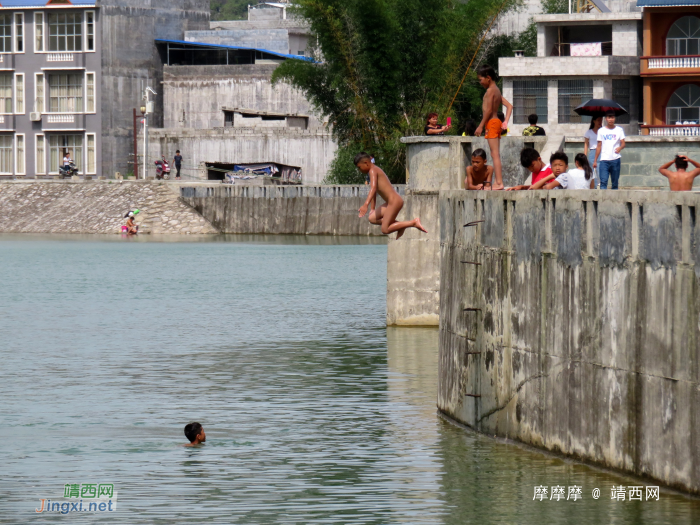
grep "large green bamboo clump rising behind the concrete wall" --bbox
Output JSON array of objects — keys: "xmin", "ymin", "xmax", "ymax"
[{"xmin": 273, "ymin": 0, "xmax": 518, "ymax": 182}]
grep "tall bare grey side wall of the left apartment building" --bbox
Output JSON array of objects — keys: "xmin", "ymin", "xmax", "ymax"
[{"xmin": 100, "ymin": 0, "xmax": 211, "ymax": 177}]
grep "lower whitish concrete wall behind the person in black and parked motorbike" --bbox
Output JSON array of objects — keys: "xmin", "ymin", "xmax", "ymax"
[{"xmin": 149, "ymin": 128, "xmax": 338, "ymax": 184}]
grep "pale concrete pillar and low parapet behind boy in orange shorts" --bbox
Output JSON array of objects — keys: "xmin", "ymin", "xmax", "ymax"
[{"xmin": 386, "ymin": 136, "xmax": 547, "ymax": 326}]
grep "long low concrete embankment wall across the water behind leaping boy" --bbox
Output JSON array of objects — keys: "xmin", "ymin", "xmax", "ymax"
[{"xmin": 181, "ymin": 184, "xmax": 404, "ymax": 235}]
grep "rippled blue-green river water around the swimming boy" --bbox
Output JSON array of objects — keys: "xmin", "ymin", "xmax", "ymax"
[{"xmin": 0, "ymin": 236, "xmax": 700, "ymax": 525}]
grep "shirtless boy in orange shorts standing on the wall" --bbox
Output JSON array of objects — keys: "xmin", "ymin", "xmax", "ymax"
[{"xmin": 474, "ymin": 65, "xmax": 513, "ymax": 190}]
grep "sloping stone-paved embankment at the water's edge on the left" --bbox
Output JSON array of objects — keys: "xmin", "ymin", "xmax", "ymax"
[{"xmin": 0, "ymin": 181, "xmax": 218, "ymax": 234}]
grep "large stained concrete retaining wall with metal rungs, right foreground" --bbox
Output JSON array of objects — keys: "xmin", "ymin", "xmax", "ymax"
[{"xmin": 438, "ymin": 191, "xmax": 700, "ymax": 494}]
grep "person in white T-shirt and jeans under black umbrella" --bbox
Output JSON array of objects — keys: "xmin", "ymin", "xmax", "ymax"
[{"xmin": 574, "ymin": 98, "xmax": 627, "ymax": 190}]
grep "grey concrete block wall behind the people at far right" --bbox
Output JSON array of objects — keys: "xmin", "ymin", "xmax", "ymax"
[{"xmin": 564, "ymin": 135, "xmax": 700, "ymax": 189}]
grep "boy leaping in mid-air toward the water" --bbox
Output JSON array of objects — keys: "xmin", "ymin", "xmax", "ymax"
[{"xmin": 355, "ymin": 153, "xmax": 428, "ymax": 239}]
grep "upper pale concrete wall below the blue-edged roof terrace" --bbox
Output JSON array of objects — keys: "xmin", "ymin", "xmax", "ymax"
[{"xmin": 162, "ymin": 65, "xmax": 323, "ymax": 129}]
